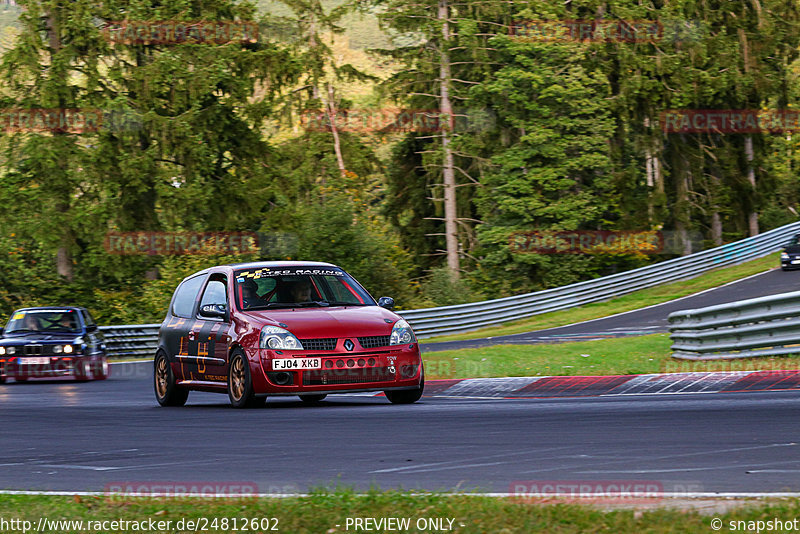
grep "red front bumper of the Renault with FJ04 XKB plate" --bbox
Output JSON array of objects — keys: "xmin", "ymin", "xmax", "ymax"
[{"xmin": 248, "ymin": 343, "xmax": 423, "ymax": 395}]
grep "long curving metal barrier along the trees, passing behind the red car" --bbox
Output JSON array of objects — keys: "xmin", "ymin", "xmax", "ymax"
[{"xmin": 101, "ymin": 222, "xmax": 800, "ymax": 356}]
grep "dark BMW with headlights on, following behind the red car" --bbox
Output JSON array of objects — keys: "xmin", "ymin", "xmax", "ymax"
[{"xmin": 0, "ymin": 306, "xmax": 108, "ymax": 383}]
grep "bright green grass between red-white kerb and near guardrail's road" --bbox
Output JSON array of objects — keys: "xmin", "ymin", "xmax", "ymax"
[{"xmin": 422, "ymin": 334, "xmax": 800, "ymax": 380}]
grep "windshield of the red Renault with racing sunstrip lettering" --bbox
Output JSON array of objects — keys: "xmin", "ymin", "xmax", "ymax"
[{"xmin": 235, "ymin": 267, "xmax": 375, "ymax": 310}]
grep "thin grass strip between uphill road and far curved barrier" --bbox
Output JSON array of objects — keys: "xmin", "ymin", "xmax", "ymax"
[{"xmin": 420, "ymin": 252, "xmax": 780, "ymax": 344}]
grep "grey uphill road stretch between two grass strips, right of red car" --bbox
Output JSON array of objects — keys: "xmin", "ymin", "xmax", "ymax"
[{"xmin": 420, "ymin": 268, "xmax": 800, "ymax": 352}]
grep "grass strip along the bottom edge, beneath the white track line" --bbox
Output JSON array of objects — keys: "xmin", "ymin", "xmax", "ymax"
[{"xmin": 0, "ymin": 491, "xmax": 800, "ymax": 534}]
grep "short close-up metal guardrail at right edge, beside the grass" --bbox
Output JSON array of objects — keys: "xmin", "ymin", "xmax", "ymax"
[{"xmin": 669, "ymin": 291, "xmax": 800, "ymax": 360}]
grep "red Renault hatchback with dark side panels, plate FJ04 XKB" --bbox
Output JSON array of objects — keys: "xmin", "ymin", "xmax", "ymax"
[{"xmin": 153, "ymin": 262, "xmax": 425, "ymax": 408}]
